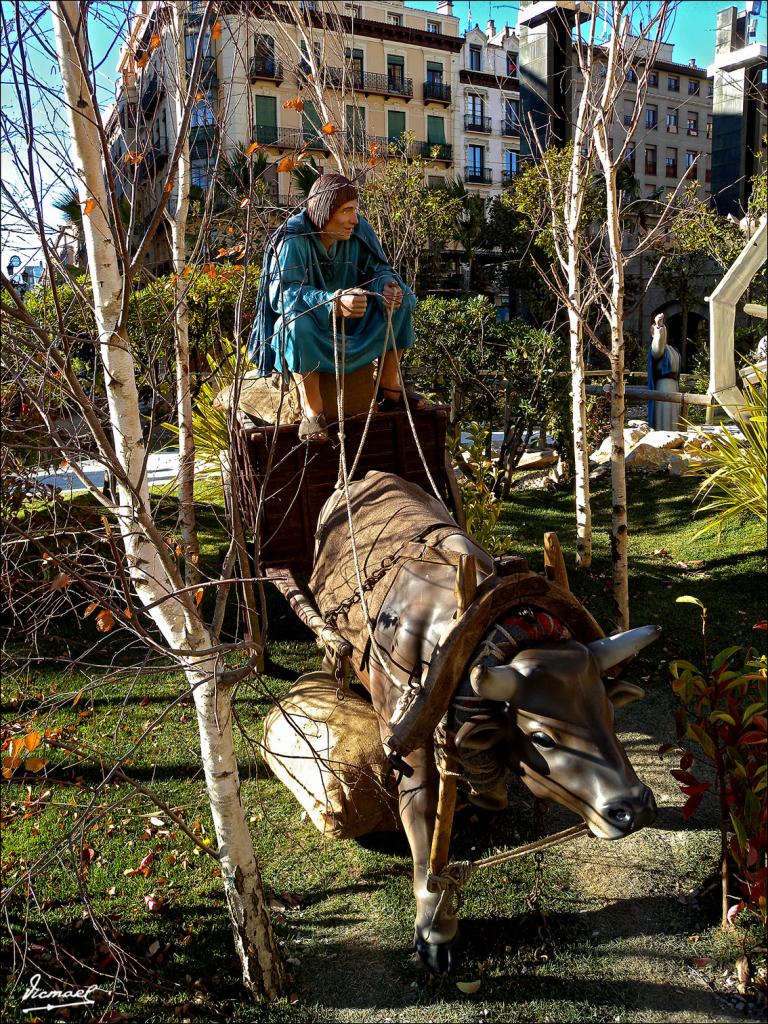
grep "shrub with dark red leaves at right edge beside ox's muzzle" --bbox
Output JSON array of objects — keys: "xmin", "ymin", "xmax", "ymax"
[{"xmin": 660, "ymin": 597, "xmax": 768, "ymax": 927}]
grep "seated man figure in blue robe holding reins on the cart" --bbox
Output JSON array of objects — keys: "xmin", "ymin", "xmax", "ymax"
[{"xmin": 249, "ymin": 174, "xmax": 421, "ymax": 441}]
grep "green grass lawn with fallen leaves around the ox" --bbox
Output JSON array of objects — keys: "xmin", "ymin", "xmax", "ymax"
[{"xmin": 2, "ymin": 476, "xmax": 767, "ymax": 1022}]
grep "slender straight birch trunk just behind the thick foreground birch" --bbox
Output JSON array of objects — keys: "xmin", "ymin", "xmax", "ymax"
[{"xmin": 170, "ymin": 0, "xmax": 200, "ymax": 586}]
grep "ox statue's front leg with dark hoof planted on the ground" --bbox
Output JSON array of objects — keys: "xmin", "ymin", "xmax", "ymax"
[{"xmin": 399, "ymin": 748, "xmax": 459, "ymax": 974}]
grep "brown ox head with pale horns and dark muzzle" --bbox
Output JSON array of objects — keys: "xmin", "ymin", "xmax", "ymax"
[{"xmin": 470, "ymin": 626, "xmax": 660, "ymax": 839}]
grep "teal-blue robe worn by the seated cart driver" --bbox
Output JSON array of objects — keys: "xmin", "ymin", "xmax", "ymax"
[{"xmin": 248, "ymin": 211, "xmax": 416, "ymax": 375}]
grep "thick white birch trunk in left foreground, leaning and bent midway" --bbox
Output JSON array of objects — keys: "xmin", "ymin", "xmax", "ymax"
[{"xmin": 50, "ymin": 0, "xmax": 285, "ymax": 998}]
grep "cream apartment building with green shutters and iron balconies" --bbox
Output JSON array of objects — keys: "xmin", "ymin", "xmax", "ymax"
[{"xmin": 108, "ymin": 0, "xmax": 464, "ymax": 218}]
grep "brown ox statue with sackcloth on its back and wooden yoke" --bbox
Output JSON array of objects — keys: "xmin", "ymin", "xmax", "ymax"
[{"xmin": 309, "ymin": 472, "xmax": 659, "ymax": 972}]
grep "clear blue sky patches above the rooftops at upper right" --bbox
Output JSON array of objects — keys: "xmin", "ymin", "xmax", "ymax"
[{"xmin": 415, "ymin": 0, "xmax": 768, "ymax": 68}]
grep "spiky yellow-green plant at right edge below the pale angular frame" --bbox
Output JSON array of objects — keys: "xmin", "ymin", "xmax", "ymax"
[{"xmin": 691, "ymin": 367, "xmax": 768, "ymax": 537}]
